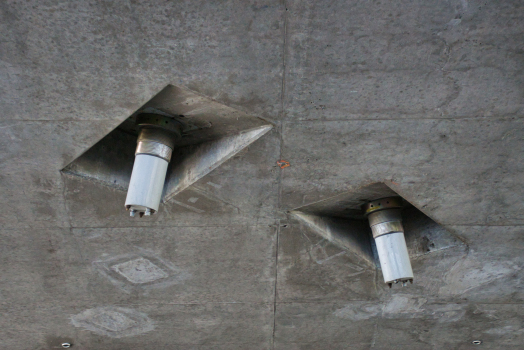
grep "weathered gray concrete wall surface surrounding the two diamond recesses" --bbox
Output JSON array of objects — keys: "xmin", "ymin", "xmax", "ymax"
[{"xmin": 0, "ymin": 0, "xmax": 524, "ymax": 350}]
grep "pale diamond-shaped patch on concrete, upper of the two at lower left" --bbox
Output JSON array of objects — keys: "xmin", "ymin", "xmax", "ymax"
[{"xmin": 93, "ymin": 249, "xmax": 191, "ymax": 293}]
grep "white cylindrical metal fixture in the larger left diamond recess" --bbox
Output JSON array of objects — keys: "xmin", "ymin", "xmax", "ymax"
[{"xmin": 125, "ymin": 113, "xmax": 182, "ymax": 217}]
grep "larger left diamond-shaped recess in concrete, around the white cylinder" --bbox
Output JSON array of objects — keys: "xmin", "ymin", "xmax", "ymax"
[{"xmin": 62, "ymin": 85, "xmax": 273, "ymax": 207}]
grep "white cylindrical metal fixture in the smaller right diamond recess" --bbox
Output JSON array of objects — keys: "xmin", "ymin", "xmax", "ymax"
[{"xmin": 363, "ymin": 197, "xmax": 413, "ymax": 288}]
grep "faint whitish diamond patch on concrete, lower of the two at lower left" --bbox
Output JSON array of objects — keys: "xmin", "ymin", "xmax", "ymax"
[{"xmin": 71, "ymin": 306, "xmax": 155, "ymax": 338}]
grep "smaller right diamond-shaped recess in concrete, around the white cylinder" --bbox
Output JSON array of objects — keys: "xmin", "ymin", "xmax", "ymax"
[{"xmin": 291, "ymin": 183, "xmax": 465, "ymax": 268}]
